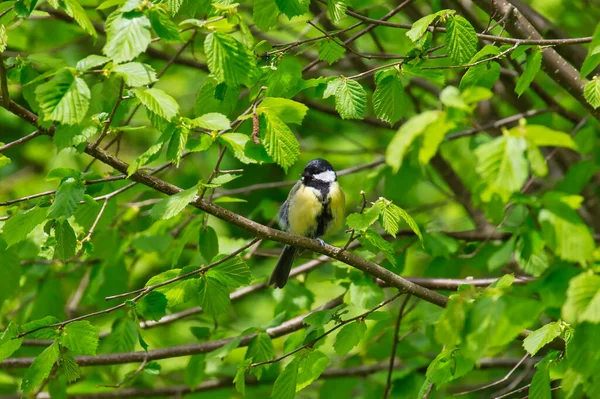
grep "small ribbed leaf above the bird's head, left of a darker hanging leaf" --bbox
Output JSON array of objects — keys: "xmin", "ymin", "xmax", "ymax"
[{"xmin": 324, "ymin": 78, "xmax": 367, "ymax": 119}]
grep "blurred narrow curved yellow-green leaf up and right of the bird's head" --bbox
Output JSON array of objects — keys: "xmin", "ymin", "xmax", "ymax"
[{"xmin": 385, "ymin": 111, "xmax": 441, "ymax": 173}]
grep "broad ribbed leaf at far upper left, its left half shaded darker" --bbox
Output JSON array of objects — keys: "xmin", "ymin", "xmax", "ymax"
[{"xmin": 35, "ymin": 69, "xmax": 91, "ymax": 125}]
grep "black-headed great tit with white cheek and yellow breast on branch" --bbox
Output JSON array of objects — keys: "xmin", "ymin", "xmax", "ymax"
[{"xmin": 269, "ymin": 158, "xmax": 346, "ymax": 288}]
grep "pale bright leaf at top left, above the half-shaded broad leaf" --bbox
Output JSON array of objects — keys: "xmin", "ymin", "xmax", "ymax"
[{"xmin": 102, "ymin": 11, "xmax": 152, "ymax": 64}]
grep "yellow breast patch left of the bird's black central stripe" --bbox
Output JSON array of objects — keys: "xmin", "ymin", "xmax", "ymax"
[{"xmin": 288, "ymin": 185, "xmax": 323, "ymax": 236}]
